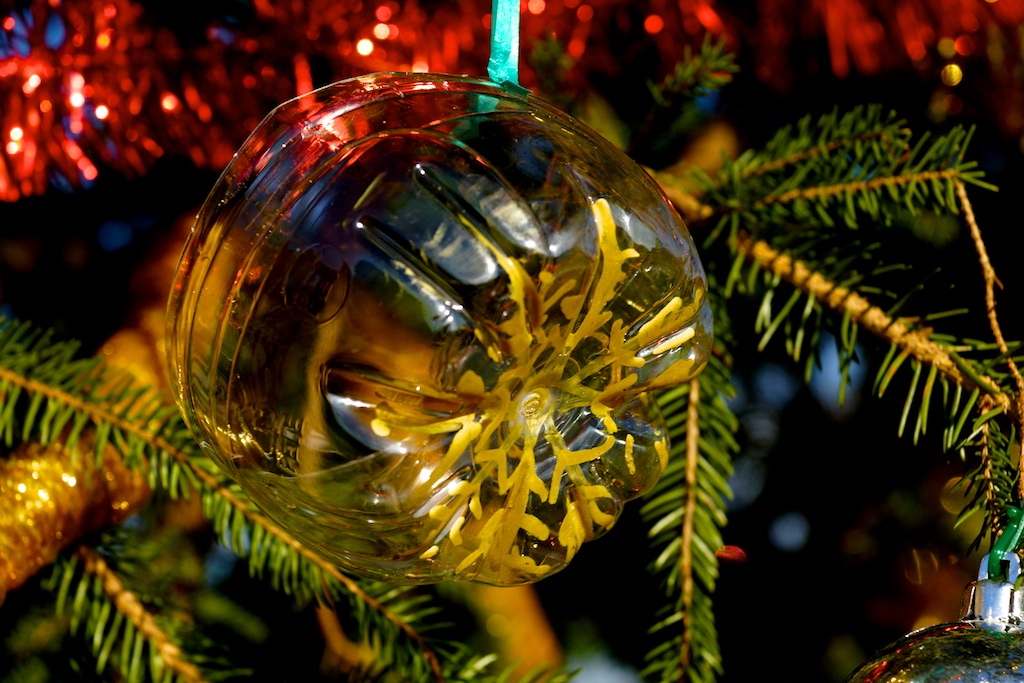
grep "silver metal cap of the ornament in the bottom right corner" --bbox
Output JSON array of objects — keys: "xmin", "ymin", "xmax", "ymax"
[{"xmin": 961, "ymin": 552, "xmax": 1024, "ymax": 633}]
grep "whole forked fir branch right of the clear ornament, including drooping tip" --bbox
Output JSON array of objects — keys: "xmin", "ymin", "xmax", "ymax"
[{"xmin": 655, "ymin": 102, "xmax": 1024, "ymax": 561}]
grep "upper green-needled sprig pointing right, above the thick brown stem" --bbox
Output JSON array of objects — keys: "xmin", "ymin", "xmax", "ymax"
[{"xmin": 655, "ymin": 106, "xmax": 992, "ymax": 244}]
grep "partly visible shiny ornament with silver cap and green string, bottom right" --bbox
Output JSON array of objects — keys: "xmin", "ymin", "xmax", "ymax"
[{"xmin": 847, "ymin": 509, "xmax": 1024, "ymax": 683}]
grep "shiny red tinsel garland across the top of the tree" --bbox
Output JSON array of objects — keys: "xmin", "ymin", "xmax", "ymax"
[{"xmin": 0, "ymin": 0, "xmax": 1024, "ymax": 202}]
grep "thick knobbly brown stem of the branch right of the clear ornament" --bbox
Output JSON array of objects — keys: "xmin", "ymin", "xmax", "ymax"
[{"xmin": 734, "ymin": 232, "xmax": 1020, "ymax": 421}]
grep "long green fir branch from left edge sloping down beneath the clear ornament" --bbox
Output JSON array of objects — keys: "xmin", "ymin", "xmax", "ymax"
[{"xmin": 0, "ymin": 322, "xmax": 452, "ymax": 680}]
